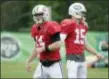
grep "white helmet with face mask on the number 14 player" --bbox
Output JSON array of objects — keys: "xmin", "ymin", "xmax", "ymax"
[{"xmin": 32, "ymin": 5, "xmax": 48, "ymax": 24}]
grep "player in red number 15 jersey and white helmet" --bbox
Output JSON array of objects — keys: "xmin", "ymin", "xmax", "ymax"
[{"xmin": 61, "ymin": 3, "xmax": 103, "ymax": 78}]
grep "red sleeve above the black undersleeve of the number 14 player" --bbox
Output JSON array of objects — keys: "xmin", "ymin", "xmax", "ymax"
[{"xmin": 48, "ymin": 22, "xmax": 61, "ymax": 35}]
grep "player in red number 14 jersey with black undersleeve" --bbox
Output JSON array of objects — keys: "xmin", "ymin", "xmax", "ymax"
[{"xmin": 27, "ymin": 5, "xmax": 62, "ymax": 78}]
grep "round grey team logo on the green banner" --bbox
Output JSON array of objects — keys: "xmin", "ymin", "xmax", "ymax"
[{"xmin": 1, "ymin": 36, "xmax": 20, "ymax": 59}]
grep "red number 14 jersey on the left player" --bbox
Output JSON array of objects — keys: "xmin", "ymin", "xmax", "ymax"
[{"xmin": 31, "ymin": 21, "xmax": 61, "ymax": 61}]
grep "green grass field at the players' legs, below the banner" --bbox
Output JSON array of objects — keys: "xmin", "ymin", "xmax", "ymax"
[{"xmin": 1, "ymin": 62, "xmax": 108, "ymax": 79}]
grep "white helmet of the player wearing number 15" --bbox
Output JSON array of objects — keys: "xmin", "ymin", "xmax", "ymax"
[{"xmin": 68, "ymin": 3, "xmax": 86, "ymax": 19}]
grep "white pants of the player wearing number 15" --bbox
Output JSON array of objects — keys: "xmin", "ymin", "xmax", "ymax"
[{"xmin": 67, "ymin": 60, "xmax": 87, "ymax": 79}]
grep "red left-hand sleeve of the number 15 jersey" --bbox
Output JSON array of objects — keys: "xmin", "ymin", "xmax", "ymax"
[{"xmin": 60, "ymin": 20, "xmax": 72, "ymax": 34}]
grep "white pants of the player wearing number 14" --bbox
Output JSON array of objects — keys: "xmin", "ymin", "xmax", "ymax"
[{"xmin": 33, "ymin": 62, "xmax": 63, "ymax": 79}]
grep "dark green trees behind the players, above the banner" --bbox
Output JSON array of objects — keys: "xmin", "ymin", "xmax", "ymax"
[{"xmin": 1, "ymin": 0, "xmax": 108, "ymax": 31}]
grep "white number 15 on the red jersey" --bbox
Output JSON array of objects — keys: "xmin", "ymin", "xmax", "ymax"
[{"xmin": 74, "ymin": 29, "xmax": 85, "ymax": 44}]
